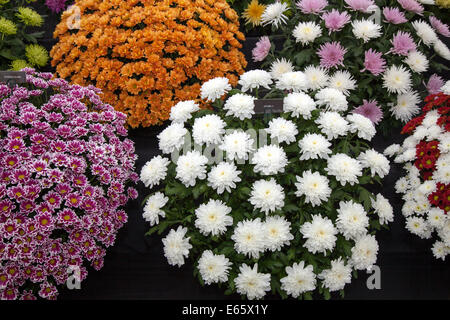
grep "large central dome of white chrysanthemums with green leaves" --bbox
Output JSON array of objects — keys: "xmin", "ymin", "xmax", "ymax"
[{"xmin": 141, "ymin": 70, "xmax": 393, "ymax": 299}]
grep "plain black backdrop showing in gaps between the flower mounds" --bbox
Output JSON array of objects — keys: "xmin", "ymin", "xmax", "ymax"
[{"xmin": 29, "ymin": 4, "xmax": 450, "ymax": 300}]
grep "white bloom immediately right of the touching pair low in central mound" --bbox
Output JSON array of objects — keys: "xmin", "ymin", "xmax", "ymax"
[{"xmin": 300, "ymin": 214, "xmax": 337, "ymax": 254}]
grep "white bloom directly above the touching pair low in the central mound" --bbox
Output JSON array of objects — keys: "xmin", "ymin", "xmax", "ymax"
[{"xmin": 249, "ymin": 178, "xmax": 284, "ymax": 214}]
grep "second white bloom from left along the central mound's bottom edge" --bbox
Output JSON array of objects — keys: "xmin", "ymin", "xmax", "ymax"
[{"xmin": 198, "ymin": 250, "xmax": 232, "ymax": 284}]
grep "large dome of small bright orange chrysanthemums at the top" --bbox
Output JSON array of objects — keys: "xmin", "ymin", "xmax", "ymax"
[{"xmin": 51, "ymin": 0, "xmax": 246, "ymax": 127}]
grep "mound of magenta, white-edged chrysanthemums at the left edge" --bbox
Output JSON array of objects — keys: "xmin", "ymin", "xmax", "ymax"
[{"xmin": 0, "ymin": 68, "xmax": 139, "ymax": 299}]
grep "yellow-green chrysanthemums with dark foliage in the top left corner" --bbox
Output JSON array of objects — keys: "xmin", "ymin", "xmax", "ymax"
[{"xmin": 0, "ymin": 0, "xmax": 49, "ymax": 71}]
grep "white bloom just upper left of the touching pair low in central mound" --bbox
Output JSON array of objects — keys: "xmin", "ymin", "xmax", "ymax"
[{"xmin": 195, "ymin": 199, "xmax": 233, "ymax": 236}]
